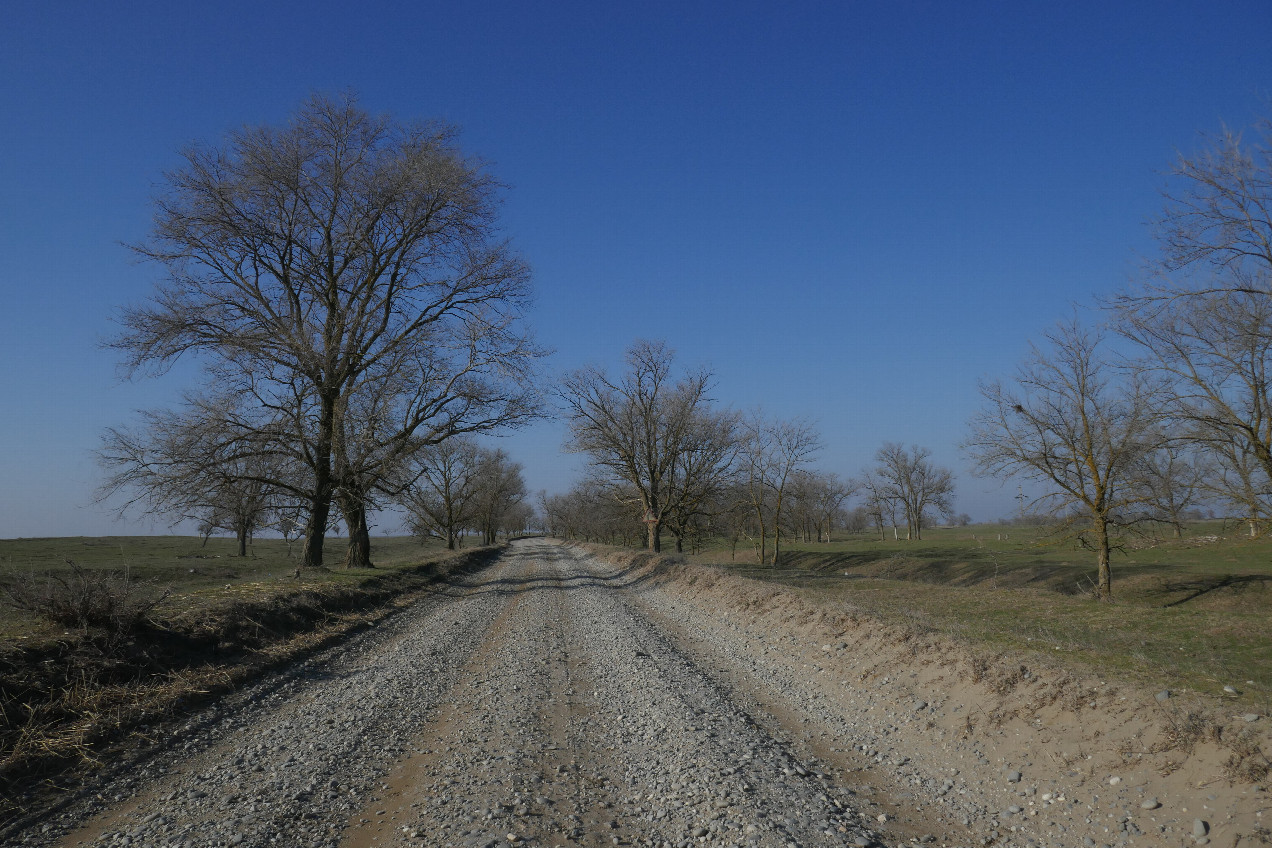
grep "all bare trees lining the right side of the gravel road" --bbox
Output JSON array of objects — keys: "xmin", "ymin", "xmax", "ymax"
[{"xmin": 557, "ymin": 112, "xmax": 1272, "ymax": 599}]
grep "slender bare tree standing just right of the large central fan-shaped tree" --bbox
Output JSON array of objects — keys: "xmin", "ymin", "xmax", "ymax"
[{"xmin": 738, "ymin": 412, "xmax": 822, "ymax": 564}]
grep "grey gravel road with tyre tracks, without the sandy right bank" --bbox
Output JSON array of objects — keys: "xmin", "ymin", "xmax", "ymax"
[{"xmin": 17, "ymin": 540, "xmax": 895, "ymax": 848}]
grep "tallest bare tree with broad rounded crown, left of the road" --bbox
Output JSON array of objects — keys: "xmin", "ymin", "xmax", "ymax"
[{"xmin": 113, "ymin": 97, "xmax": 539, "ymax": 566}]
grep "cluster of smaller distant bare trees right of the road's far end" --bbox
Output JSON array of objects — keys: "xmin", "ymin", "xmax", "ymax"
[{"xmin": 542, "ymin": 341, "xmax": 954, "ymax": 563}]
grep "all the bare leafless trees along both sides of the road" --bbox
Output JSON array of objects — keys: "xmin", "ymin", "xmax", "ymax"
[{"xmin": 100, "ymin": 97, "xmax": 1272, "ymax": 598}]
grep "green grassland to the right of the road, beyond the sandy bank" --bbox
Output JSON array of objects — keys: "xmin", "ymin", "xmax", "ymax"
[{"xmin": 695, "ymin": 523, "xmax": 1272, "ymax": 715}]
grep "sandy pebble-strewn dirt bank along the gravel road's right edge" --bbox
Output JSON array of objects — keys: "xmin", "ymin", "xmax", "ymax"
[{"xmin": 597, "ymin": 549, "xmax": 1272, "ymax": 847}]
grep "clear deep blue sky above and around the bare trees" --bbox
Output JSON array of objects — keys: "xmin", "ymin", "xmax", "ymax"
[{"xmin": 0, "ymin": 0, "xmax": 1272, "ymax": 538}]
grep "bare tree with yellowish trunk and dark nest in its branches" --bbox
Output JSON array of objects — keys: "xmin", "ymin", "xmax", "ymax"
[{"xmin": 964, "ymin": 322, "xmax": 1160, "ymax": 599}]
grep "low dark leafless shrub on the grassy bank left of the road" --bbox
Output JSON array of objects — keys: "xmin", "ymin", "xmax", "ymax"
[{"xmin": 3, "ymin": 561, "xmax": 168, "ymax": 636}]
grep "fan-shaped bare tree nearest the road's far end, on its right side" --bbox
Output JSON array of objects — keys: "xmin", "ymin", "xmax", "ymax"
[{"xmin": 560, "ymin": 341, "xmax": 711, "ymax": 552}]
